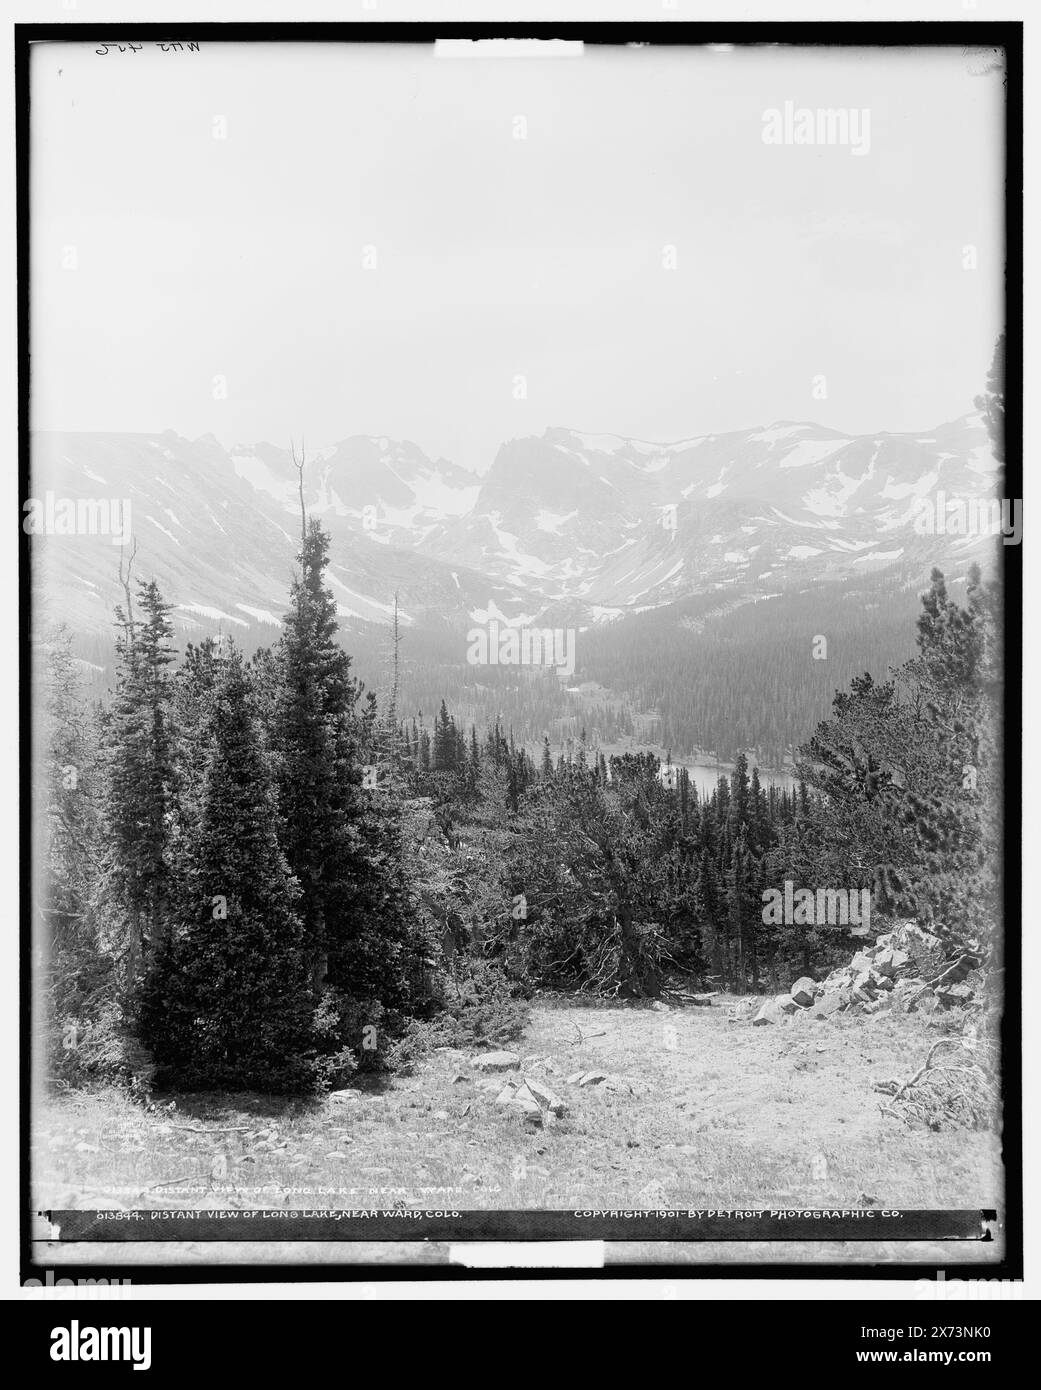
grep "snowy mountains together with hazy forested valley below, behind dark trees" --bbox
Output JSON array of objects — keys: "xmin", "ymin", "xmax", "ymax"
[{"xmin": 33, "ymin": 414, "xmax": 997, "ymax": 769}]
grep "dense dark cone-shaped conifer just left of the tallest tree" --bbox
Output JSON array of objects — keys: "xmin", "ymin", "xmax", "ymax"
[{"xmin": 143, "ymin": 651, "xmax": 311, "ymax": 1091}]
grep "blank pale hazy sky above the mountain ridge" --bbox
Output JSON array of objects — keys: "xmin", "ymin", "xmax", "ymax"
[{"xmin": 32, "ymin": 43, "xmax": 1003, "ymax": 470}]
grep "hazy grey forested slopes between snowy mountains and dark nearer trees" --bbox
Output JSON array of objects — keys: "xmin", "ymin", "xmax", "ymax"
[{"xmin": 58, "ymin": 558, "xmax": 933, "ymax": 769}]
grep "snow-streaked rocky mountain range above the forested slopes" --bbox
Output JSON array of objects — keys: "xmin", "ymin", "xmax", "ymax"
[{"xmin": 32, "ymin": 414, "xmax": 997, "ymax": 632}]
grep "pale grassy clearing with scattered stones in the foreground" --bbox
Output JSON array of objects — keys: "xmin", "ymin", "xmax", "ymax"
[{"xmin": 33, "ymin": 998, "xmax": 1002, "ymax": 1209}]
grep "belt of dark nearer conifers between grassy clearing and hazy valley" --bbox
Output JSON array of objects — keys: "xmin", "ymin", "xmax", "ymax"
[{"xmin": 38, "ymin": 521, "xmax": 1001, "ymax": 1091}]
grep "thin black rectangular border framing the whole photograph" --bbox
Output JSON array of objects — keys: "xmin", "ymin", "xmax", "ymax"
[{"xmin": 11, "ymin": 21, "xmax": 1023, "ymax": 1284}]
